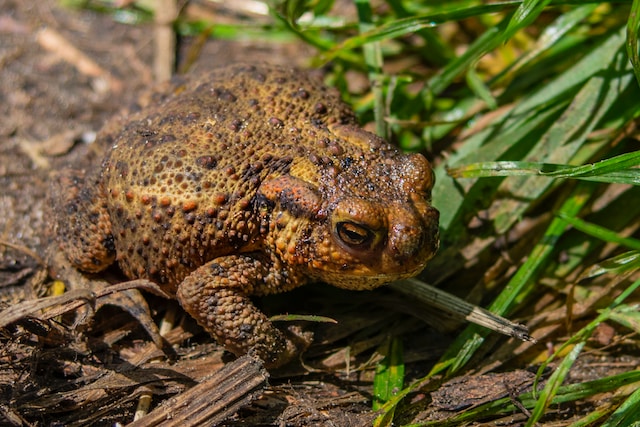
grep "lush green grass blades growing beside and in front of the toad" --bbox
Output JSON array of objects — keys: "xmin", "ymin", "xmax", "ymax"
[{"xmin": 66, "ymin": 0, "xmax": 640, "ymax": 426}]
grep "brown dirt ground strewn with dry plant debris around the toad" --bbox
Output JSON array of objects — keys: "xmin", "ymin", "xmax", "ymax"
[{"xmin": 0, "ymin": 0, "xmax": 637, "ymax": 426}]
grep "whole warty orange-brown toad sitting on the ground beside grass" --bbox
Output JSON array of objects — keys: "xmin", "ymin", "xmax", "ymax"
[{"xmin": 56, "ymin": 65, "xmax": 438, "ymax": 366}]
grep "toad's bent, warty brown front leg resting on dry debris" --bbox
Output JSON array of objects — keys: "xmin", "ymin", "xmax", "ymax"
[{"xmin": 177, "ymin": 255, "xmax": 310, "ymax": 367}]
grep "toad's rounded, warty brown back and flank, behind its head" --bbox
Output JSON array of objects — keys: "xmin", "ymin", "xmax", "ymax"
[{"xmin": 103, "ymin": 66, "xmax": 354, "ymax": 285}]
